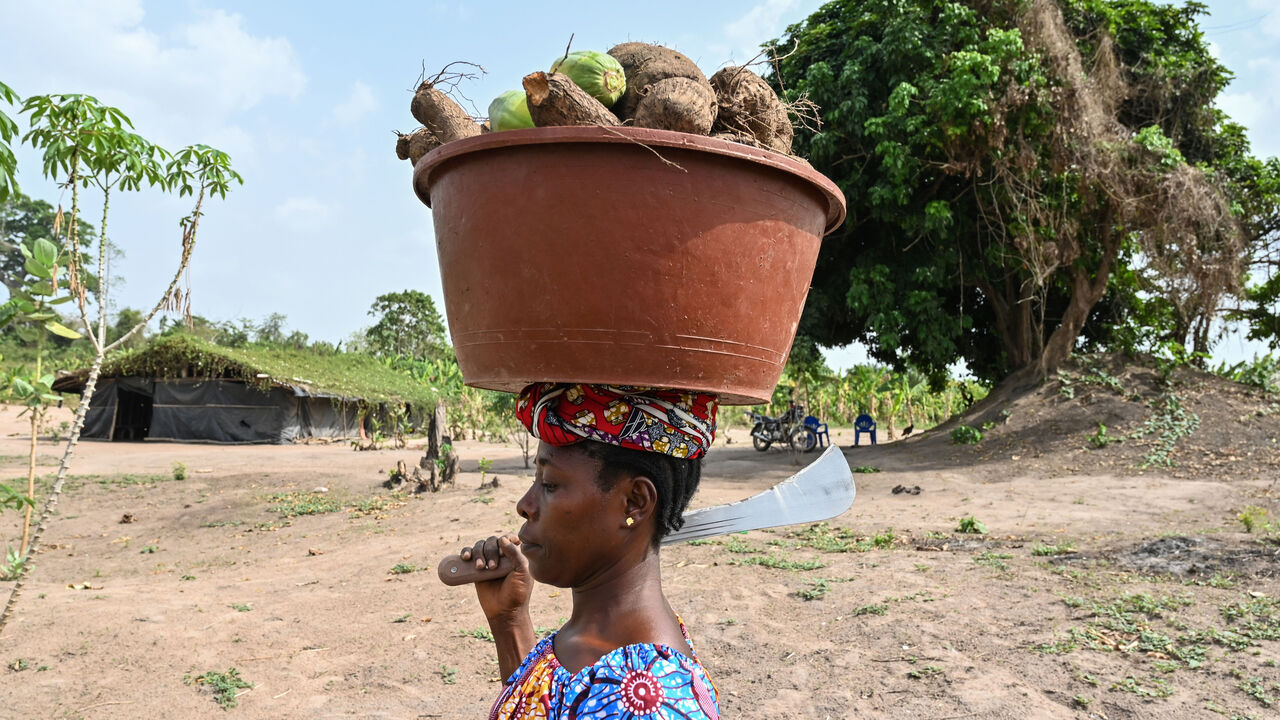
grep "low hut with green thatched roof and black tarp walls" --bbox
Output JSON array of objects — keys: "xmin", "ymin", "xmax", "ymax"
[{"xmin": 54, "ymin": 334, "xmax": 434, "ymax": 443}]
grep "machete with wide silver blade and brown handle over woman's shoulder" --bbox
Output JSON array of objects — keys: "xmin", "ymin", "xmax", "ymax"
[{"xmin": 436, "ymin": 445, "xmax": 858, "ymax": 585}]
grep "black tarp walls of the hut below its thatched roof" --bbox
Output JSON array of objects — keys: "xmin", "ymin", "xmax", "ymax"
[{"xmin": 81, "ymin": 378, "xmax": 360, "ymax": 443}]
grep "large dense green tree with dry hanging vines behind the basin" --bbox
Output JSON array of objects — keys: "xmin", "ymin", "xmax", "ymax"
[{"xmin": 771, "ymin": 0, "xmax": 1248, "ymax": 380}]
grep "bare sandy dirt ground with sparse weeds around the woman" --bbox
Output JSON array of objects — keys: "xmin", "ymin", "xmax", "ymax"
[{"xmin": 0, "ymin": 368, "xmax": 1280, "ymax": 720}]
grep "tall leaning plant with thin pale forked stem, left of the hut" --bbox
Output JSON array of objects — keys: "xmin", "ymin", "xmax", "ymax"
[{"xmin": 0, "ymin": 87, "xmax": 243, "ymax": 632}]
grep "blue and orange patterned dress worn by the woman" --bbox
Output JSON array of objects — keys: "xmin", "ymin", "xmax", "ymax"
[{"xmin": 489, "ymin": 623, "xmax": 719, "ymax": 720}]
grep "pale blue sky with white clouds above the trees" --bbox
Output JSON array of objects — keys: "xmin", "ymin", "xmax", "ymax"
[{"xmin": 0, "ymin": 0, "xmax": 1280, "ymax": 369}]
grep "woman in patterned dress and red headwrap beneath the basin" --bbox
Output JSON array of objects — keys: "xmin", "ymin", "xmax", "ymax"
[{"xmin": 461, "ymin": 383, "xmax": 719, "ymax": 720}]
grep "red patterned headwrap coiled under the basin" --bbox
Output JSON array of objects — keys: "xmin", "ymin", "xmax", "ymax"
[{"xmin": 516, "ymin": 383, "xmax": 719, "ymax": 459}]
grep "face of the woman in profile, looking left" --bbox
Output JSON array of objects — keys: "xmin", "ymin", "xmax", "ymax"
[{"xmin": 516, "ymin": 443, "xmax": 626, "ymax": 588}]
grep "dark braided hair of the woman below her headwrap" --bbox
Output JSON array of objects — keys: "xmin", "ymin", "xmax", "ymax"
[{"xmin": 582, "ymin": 441, "xmax": 703, "ymax": 547}]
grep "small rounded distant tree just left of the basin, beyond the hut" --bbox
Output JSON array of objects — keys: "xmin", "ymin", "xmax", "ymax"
[{"xmin": 365, "ymin": 290, "xmax": 448, "ymax": 361}]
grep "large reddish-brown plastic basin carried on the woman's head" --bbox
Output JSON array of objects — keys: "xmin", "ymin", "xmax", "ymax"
[{"xmin": 413, "ymin": 127, "xmax": 845, "ymax": 405}]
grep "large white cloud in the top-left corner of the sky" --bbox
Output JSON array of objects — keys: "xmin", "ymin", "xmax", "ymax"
[{"xmin": 0, "ymin": 0, "xmax": 307, "ymax": 146}]
